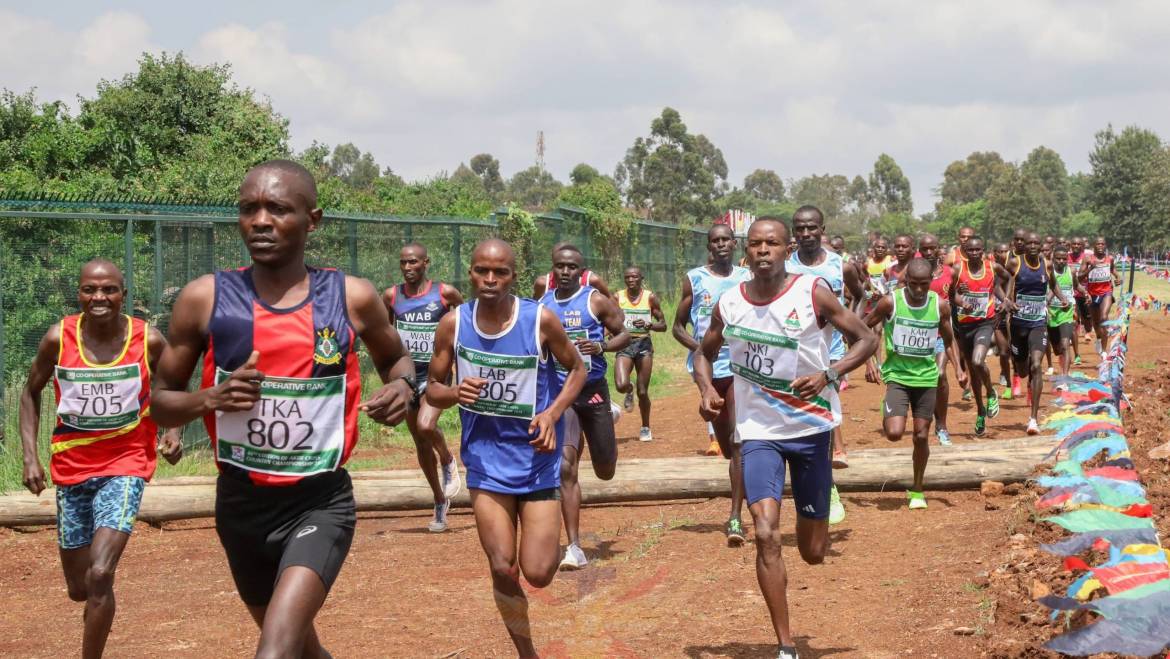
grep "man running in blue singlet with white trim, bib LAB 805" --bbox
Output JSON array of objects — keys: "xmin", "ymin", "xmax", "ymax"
[{"xmin": 427, "ymin": 239, "xmax": 586, "ymax": 657}]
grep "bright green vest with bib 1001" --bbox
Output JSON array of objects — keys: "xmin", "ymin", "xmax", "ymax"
[{"xmin": 881, "ymin": 288, "xmax": 940, "ymax": 386}]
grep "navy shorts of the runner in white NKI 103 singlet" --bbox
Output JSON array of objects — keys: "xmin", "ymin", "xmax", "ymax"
[{"xmin": 741, "ymin": 431, "xmax": 833, "ymax": 520}]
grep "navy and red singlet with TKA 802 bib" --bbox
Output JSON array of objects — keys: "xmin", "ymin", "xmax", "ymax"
[{"xmin": 202, "ymin": 268, "xmax": 362, "ymax": 486}]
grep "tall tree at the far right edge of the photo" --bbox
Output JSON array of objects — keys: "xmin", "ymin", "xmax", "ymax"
[{"xmin": 1089, "ymin": 125, "xmax": 1165, "ymax": 246}]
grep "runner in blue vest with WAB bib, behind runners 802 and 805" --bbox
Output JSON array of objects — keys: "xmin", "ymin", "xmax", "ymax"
[{"xmin": 381, "ymin": 242, "xmax": 463, "ymax": 533}]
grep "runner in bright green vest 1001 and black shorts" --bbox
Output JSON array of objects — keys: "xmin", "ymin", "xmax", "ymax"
[{"xmin": 866, "ymin": 258, "xmax": 966, "ymax": 510}]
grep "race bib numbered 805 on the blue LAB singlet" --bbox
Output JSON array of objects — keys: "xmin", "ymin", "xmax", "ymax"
[{"xmin": 455, "ymin": 345, "xmax": 537, "ymax": 419}]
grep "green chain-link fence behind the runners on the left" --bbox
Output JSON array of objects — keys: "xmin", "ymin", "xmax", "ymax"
[{"xmin": 0, "ymin": 199, "xmax": 706, "ymax": 447}]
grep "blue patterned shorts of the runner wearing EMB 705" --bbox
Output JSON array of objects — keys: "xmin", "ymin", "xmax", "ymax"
[{"xmin": 57, "ymin": 476, "xmax": 146, "ymax": 549}]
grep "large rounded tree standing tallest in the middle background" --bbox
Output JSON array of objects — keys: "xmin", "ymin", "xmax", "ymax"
[{"xmin": 614, "ymin": 108, "xmax": 728, "ymax": 224}]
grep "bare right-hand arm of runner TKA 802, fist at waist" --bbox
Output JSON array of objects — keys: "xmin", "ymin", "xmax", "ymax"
[{"xmin": 345, "ymin": 275, "xmax": 414, "ymax": 425}]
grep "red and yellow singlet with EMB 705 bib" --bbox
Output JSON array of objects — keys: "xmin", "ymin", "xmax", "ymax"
[{"xmin": 49, "ymin": 315, "xmax": 158, "ymax": 485}]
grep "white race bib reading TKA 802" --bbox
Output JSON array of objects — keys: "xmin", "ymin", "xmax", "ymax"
[{"xmin": 215, "ymin": 369, "xmax": 345, "ymax": 476}]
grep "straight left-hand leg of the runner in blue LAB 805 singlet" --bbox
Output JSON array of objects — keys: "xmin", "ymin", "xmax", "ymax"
[{"xmin": 470, "ymin": 489, "xmax": 538, "ymax": 658}]
